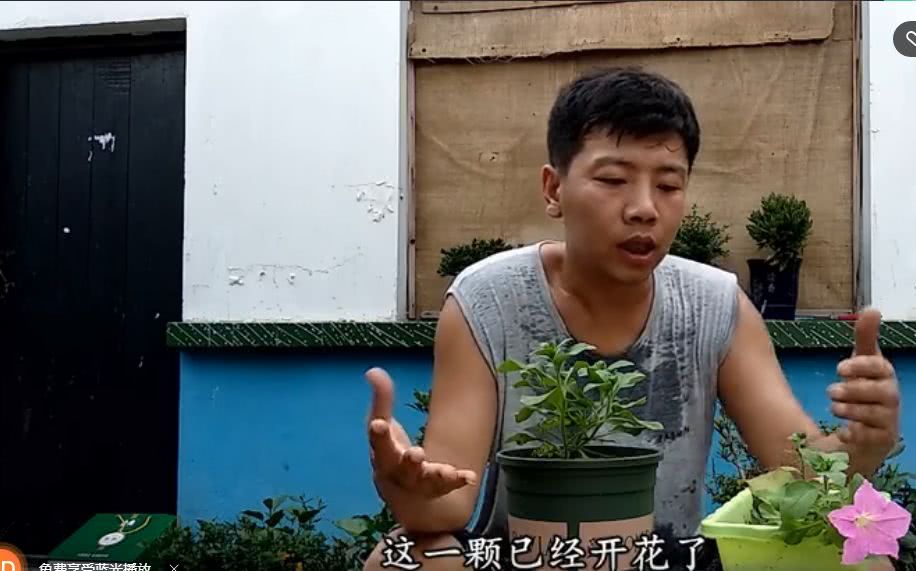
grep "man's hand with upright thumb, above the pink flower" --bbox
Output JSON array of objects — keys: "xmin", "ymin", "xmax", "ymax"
[{"xmin": 828, "ymin": 309, "xmax": 900, "ymax": 477}]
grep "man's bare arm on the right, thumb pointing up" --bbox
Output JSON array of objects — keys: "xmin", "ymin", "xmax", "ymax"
[{"xmin": 719, "ymin": 292, "xmax": 900, "ymax": 477}]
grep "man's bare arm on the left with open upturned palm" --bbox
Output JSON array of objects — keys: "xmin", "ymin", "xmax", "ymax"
[{"xmin": 370, "ymin": 297, "xmax": 497, "ymax": 533}]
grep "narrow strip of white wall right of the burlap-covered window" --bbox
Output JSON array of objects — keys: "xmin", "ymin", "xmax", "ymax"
[{"xmin": 862, "ymin": 2, "xmax": 916, "ymax": 320}]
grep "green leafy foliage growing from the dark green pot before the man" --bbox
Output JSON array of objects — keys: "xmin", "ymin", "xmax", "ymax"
[{"xmin": 499, "ymin": 339, "xmax": 662, "ymax": 458}]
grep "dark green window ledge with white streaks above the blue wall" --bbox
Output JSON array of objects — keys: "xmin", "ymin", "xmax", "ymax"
[{"xmin": 167, "ymin": 319, "xmax": 916, "ymax": 349}]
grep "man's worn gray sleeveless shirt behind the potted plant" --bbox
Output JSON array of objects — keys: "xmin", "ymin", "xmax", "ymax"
[{"xmin": 446, "ymin": 243, "xmax": 738, "ymax": 538}]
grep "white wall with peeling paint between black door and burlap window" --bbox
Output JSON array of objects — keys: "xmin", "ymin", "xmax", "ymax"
[{"xmin": 0, "ymin": 0, "xmax": 406, "ymax": 320}]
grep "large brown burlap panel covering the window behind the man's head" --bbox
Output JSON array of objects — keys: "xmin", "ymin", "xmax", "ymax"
[{"xmin": 414, "ymin": 24, "xmax": 855, "ymax": 312}]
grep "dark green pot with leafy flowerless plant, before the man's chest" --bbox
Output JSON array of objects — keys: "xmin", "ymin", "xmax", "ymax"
[{"xmin": 497, "ymin": 339, "xmax": 662, "ymax": 569}]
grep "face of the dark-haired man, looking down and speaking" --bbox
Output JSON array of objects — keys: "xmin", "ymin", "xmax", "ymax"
[{"xmin": 544, "ymin": 128, "xmax": 688, "ymax": 283}]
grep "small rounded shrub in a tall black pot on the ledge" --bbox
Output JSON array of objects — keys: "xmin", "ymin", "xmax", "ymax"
[{"xmin": 747, "ymin": 194, "xmax": 812, "ymax": 320}]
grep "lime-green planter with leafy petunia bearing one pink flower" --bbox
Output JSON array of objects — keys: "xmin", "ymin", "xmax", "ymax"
[{"xmin": 700, "ymin": 434, "xmax": 911, "ymax": 571}]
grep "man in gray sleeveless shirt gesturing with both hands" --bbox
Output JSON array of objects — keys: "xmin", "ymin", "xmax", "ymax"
[{"xmin": 366, "ymin": 69, "xmax": 899, "ymax": 569}]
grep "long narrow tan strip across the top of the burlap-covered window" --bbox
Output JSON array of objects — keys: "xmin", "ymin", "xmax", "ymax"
[{"xmin": 409, "ymin": 0, "xmax": 849, "ymax": 59}]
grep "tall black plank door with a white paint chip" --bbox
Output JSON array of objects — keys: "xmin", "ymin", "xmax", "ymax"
[{"xmin": 0, "ymin": 34, "xmax": 185, "ymax": 554}]
